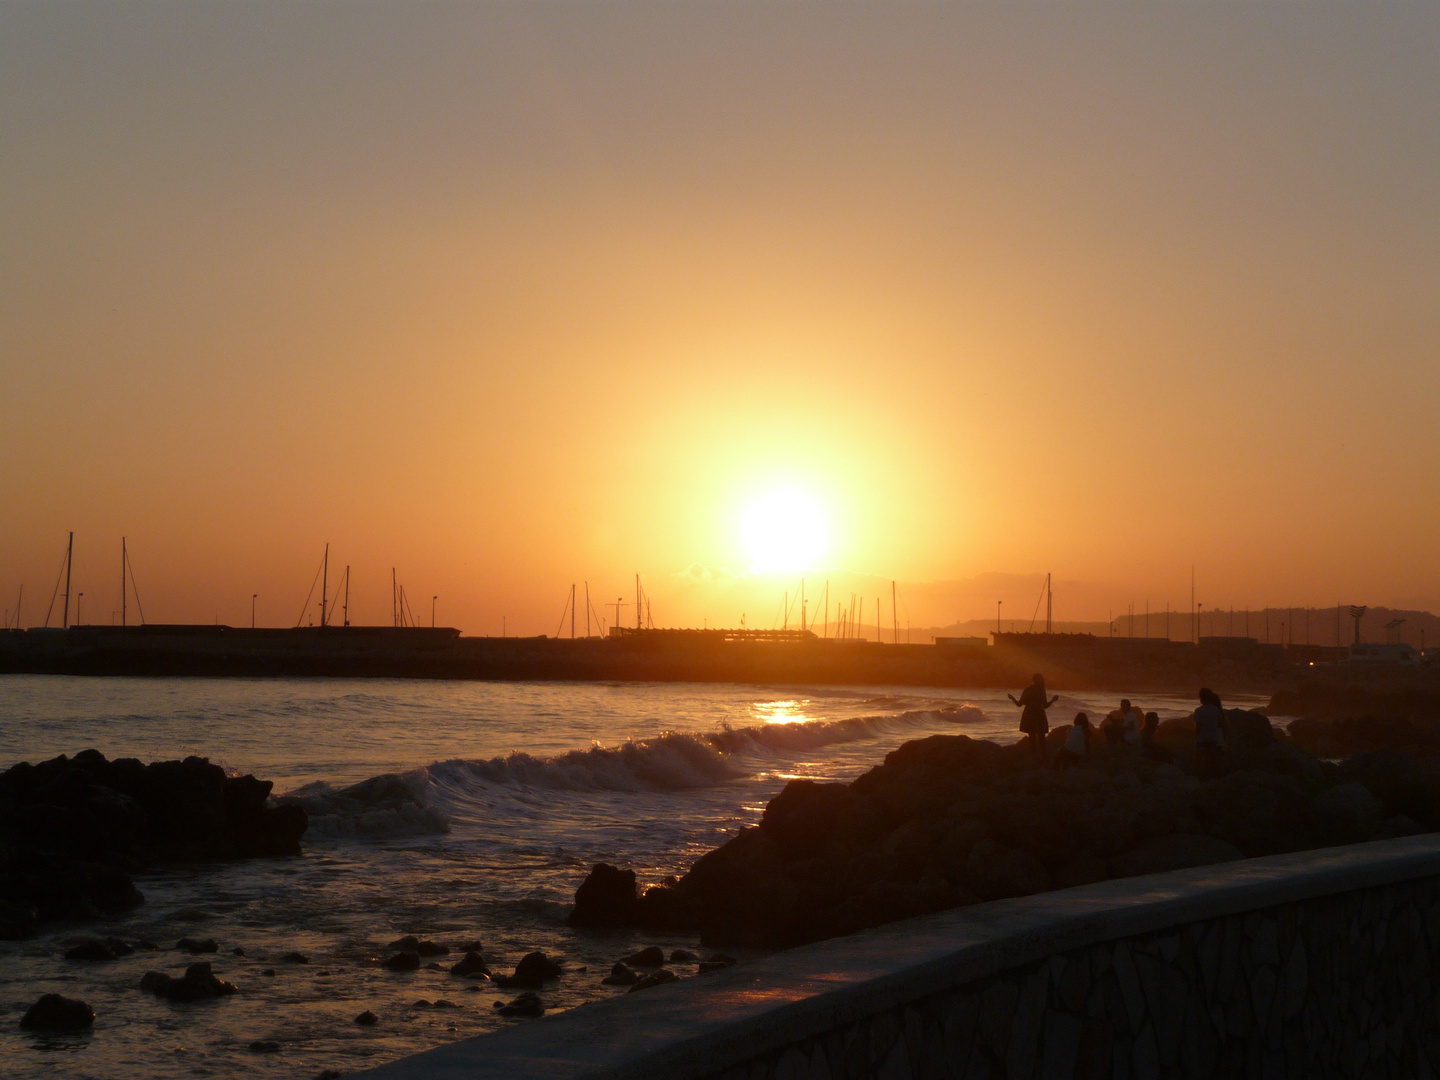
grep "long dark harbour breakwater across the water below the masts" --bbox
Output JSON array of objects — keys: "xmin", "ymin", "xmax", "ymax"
[{"xmin": 0, "ymin": 625, "xmax": 1299, "ymax": 694}]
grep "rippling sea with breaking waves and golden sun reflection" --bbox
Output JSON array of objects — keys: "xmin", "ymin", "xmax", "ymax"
[{"xmin": 0, "ymin": 675, "xmax": 1263, "ymax": 1080}]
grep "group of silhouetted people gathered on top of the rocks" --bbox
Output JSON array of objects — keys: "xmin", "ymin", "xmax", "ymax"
[{"xmin": 1008, "ymin": 674, "xmax": 1225, "ymax": 776}]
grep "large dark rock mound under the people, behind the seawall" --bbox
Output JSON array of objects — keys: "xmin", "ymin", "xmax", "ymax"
[{"xmin": 570, "ymin": 710, "xmax": 1440, "ymax": 948}]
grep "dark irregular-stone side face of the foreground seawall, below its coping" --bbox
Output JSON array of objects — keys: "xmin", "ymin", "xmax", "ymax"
[{"xmin": 719, "ymin": 878, "xmax": 1440, "ymax": 1080}]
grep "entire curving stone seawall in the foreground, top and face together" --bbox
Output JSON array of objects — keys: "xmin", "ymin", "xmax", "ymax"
[{"xmin": 354, "ymin": 834, "xmax": 1440, "ymax": 1080}]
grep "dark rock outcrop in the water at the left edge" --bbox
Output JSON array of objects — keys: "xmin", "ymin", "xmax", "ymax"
[{"xmin": 0, "ymin": 750, "xmax": 307, "ymax": 940}]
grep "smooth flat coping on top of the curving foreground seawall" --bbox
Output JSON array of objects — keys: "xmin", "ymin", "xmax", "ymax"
[{"xmin": 356, "ymin": 834, "xmax": 1440, "ymax": 1080}]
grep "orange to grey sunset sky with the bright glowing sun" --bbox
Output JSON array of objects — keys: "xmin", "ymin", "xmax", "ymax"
[{"xmin": 0, "ymin": 0, "xmax": 1440, "ymax": 634}]
